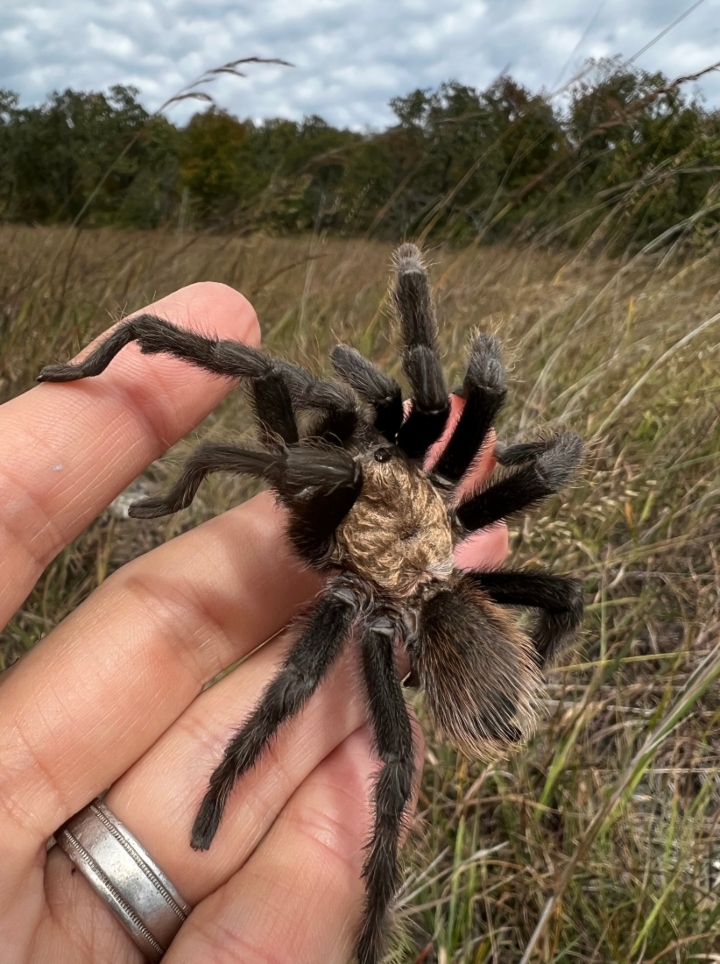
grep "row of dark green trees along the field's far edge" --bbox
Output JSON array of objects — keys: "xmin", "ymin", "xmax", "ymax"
[{"xmin": 0, "ymin": 58, "xmax": 720, "ymax": 248}]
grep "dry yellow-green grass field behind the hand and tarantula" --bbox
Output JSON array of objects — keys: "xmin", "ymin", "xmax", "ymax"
[{"xmin": 0, "ymin": 227, "xmax": 720, "ymax": 964}]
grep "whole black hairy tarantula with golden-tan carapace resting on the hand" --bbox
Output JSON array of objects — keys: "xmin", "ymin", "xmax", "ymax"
[{"xmin": 39, "ymin": 244, "xmax": 583, "ymax": 964}]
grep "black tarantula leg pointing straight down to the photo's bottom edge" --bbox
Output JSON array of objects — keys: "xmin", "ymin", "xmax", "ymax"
[{"xmin": 358, "ymin": 615, "xmax": 415, "ymax": 964}]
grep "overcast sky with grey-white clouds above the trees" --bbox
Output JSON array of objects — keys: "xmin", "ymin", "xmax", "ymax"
[{"xmin": 0, "ymin": 0, "xmax": 720, "ymax": 129}]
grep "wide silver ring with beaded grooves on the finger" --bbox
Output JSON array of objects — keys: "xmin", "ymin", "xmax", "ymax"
[{"xmin": 55, "ymin": 800, "xmax": 192, "ymax": 962}]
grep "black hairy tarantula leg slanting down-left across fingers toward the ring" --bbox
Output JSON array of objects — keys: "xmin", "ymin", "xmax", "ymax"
[{"xmin": 191, "ymin": 577, "xmax": 360, "ymax": 850}]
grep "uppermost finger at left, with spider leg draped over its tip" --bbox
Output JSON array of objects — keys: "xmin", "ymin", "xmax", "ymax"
[{"xmin": 0, "ymin": 282, "xmax": 260, "ymax": 625}]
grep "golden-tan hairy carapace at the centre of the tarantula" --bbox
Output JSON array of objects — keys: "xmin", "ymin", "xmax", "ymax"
[{"xmin": 335, "ymin": 458, "xmax": 453, "ymax": 598}]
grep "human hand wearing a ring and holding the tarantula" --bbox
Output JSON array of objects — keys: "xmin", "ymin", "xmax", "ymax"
[{"xmin": 0, "ymin": 284, "xmax": 507, "ymax": 964}]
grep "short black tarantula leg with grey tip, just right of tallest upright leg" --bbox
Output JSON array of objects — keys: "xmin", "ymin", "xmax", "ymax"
[{"xmin": 431, "ymin": 334, "xmax": 507, "ymax": 486}]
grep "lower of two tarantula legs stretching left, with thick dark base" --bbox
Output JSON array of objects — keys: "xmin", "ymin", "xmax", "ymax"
[{"xmin": 129, "ymin": 442, "xmax": 362, "ymax": 562}]
